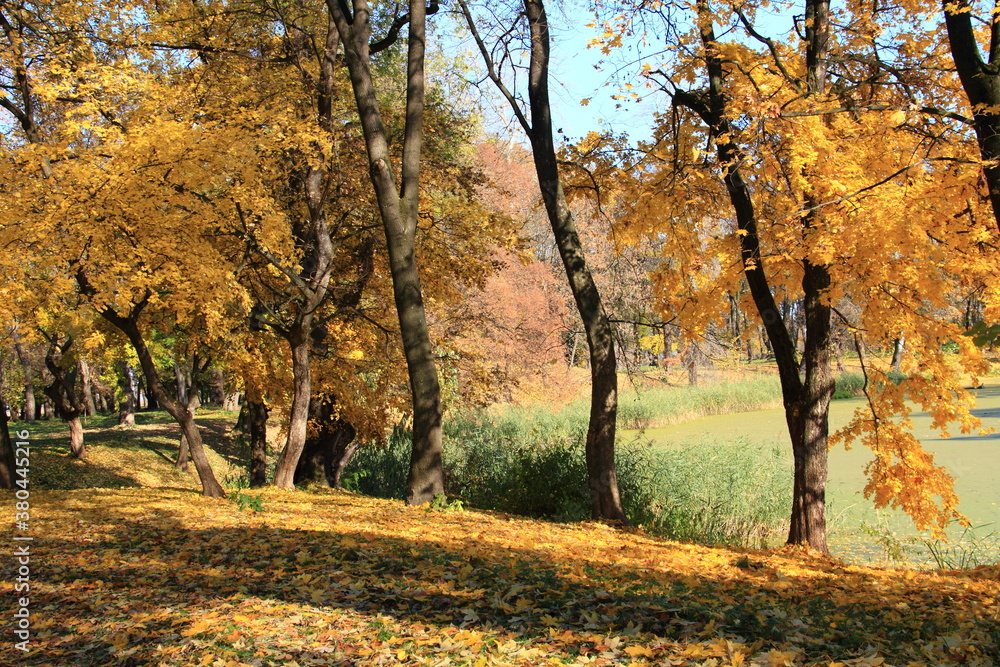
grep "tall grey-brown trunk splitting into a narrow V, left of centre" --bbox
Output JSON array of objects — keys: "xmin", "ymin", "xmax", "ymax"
[{"xmin": 326, "ymin": 0, "xmax": 444, "ymax": 505}]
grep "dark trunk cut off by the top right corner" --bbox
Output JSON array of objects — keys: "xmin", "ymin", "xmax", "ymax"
[{"xmin": 941, "ymin": 0, "xmax": 1000, "ymax": 227}]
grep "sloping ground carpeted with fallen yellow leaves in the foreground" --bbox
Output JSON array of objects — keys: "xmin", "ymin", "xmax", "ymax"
[{"xmin": 7, "ymin": 489, "xmax": 1000, "ymax": 667}]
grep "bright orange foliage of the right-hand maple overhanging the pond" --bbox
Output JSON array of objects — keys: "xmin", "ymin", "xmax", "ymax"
[{"xmin": 581, "ymin": 2, "xmax": 1000, "ymax": 530}]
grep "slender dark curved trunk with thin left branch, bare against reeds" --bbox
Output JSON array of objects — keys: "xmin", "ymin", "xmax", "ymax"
[{"xmin": 460, "ymin": 0, "xmax": 628, "ymax": 524}]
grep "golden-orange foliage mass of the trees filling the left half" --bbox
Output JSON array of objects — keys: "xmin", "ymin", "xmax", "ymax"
[{"xmin": 0, "ymin": 2, "xmax": 513, "ymax": 486}]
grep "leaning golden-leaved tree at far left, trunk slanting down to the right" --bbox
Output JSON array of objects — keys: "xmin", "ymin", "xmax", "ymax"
[{"xmin": 2, "ymin": 1, "xmax": 238, "ymax": 497}]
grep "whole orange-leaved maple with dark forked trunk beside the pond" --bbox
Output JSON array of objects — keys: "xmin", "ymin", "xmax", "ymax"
[{"xmin": 592, "ymin": 0, "xmax": 990, "ymax": 551}]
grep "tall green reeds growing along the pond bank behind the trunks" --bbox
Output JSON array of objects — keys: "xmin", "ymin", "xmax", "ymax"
[{"xmin": 345, "ymin": 382, "xmax": 791, "ymax": 546}]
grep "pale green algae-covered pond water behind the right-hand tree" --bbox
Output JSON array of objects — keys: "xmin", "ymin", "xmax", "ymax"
[{"xmin": 622, "ymin": 379, "xmax": 1000, "ymax": 566}]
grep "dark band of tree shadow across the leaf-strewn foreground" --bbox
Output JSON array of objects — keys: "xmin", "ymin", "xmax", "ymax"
[{"xmin": 19, "ymin": 494, "xmax": 1000, "ymax": 665}]
